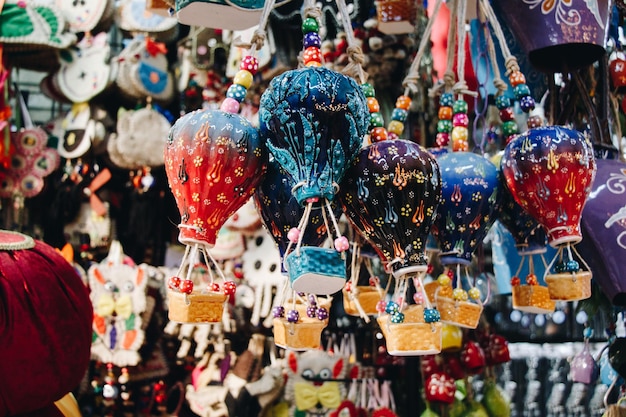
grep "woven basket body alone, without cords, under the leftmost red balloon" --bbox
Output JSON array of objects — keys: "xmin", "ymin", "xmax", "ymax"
[{"xmin": 167, "ymin": 289, "xmax": 226, "ymax": 323}]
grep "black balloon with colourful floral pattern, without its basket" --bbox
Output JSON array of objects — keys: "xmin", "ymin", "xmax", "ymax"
[{"xmin": 339, "ymin": 139, "xmax": 441, "ymax": 277}]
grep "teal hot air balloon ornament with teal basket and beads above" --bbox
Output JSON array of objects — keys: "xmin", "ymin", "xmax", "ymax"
[{"xmin": 259, "ymin": 10, "xmax": 368, "ymax": 294}]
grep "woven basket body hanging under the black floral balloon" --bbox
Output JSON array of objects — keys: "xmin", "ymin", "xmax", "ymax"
[{"xmin": 377, "ymin": 305, "xmax": 442, "ymax": 356}]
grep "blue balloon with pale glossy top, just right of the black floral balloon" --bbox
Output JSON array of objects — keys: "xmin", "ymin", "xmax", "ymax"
[{"xmin": 433, "ymin": 152, "xmax": 498, "ymax": 266}]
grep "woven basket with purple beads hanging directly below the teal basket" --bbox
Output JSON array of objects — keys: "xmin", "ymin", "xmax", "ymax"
[{"xmin": 273, "ymin": 316, "xmax": 328, "ymax": 350}]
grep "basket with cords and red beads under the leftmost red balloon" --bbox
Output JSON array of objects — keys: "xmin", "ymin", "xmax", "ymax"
[{"xmin": 167, "ymin": 244, "xmax": 235, "ymax": 323}]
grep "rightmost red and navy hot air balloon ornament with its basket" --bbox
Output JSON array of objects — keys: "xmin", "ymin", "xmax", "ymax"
[{"xmin": 502, "ymin": 126, "xmax": 596, "ymax": 301}]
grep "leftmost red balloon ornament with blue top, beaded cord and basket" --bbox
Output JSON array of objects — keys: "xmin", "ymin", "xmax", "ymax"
[{"xmin": 165, "ymin": 50, "xmax": 266, "ymax": 322}]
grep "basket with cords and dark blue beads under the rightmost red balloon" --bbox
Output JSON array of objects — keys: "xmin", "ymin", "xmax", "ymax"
[{"xmin": 544, "ymin": 243, "xmax": 592, "ymax": 301}]
